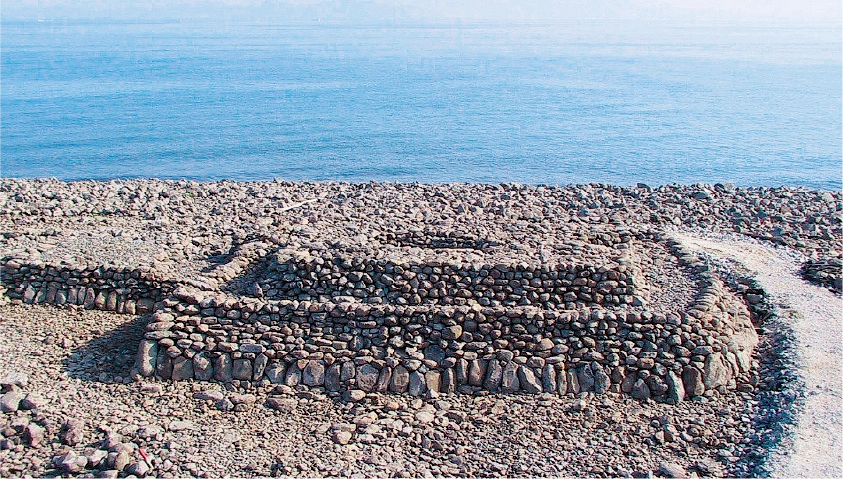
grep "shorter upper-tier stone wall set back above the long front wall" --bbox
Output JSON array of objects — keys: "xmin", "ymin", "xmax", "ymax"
[{"xmin": 258, "ymin": 251, "xmax": 640, "ymax": 308}]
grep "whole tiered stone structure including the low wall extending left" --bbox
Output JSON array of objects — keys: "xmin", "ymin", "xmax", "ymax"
[{"xmin": 0, "ymin": 225, "xmax": 758, "ymax": 403}]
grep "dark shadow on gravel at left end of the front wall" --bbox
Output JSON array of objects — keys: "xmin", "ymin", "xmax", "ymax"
[{"xmin": 63, "ymin": 315, "xmax": 152, "ymax": 384}]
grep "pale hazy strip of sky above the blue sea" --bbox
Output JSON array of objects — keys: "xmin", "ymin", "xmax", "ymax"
[{"xmin": 0, "ymin": 0, "xmax": 843, "ymax": 25}]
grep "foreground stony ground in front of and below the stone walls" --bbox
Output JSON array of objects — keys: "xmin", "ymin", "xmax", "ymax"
[{"xmin": 0, "ymin": 305, "xmax": 753, "ymax": 478}]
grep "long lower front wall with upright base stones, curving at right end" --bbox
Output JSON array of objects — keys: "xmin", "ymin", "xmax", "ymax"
[{"xmin": 138, "ymin": 268, "xmax": 757, "ymax": 402}]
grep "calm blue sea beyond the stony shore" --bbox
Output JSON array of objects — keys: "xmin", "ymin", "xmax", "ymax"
[{"xmin": 0, "ymin": 21, "xmax": 843, "ymax": 189}]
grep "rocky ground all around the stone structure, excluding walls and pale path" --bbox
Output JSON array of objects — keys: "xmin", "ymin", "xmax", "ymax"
[{"xmin": 0, "ymin": 180, "xmax": 843, "ymax": 478}]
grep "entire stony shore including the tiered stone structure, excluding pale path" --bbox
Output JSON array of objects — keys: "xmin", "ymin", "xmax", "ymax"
[{"xmin": 0, "ymin": 180, "xmax": 843, "ymax": 478}]
